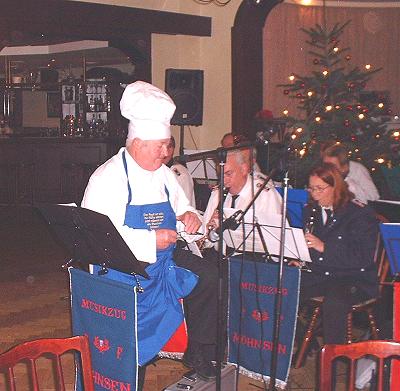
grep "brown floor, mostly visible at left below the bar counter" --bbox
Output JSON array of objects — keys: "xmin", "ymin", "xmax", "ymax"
[{"xmin": 0, "ymin": 207, "xmax": 362, "ymax": 391}]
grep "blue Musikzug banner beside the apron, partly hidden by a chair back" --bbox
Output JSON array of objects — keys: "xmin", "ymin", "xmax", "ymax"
[{"xmin": 69, "ymin": 268, "xmax": 138, "ymax": 391}]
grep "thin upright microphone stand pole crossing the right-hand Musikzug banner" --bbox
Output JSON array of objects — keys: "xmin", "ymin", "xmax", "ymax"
[{"xmin": 268, "ymin": 171, "xmax": 289, "ymax": 391}]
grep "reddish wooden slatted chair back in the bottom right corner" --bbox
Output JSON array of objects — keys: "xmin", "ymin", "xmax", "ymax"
[{"xmin": 319, "ymin": 340, "xmax": 400, "ymax": 391}]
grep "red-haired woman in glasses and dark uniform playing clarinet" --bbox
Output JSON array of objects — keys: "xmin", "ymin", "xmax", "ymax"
[{"xmin": 300, "ymin": 164, "xmax": 378, "ymax": 344}]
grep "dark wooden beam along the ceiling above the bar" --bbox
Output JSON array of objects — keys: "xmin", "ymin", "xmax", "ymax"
[{"xmin": 0, "ymin": 0, "xmax": 211, "ymax": 40}]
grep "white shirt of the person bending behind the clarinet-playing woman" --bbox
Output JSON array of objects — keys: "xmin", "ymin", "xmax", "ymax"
[{"xmin": 345, "ymin": 160, "xmax": 379, "ymax": 204}]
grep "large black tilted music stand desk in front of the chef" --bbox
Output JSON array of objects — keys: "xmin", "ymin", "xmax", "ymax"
[{"xmin": 35, "ymin": 204, "xmax": 149, "ymax": 278}]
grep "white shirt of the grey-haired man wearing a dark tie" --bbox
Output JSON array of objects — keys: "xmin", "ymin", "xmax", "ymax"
[{"xmin": 203, "ymin": 175, "xmax": 282, "ymax": 254}]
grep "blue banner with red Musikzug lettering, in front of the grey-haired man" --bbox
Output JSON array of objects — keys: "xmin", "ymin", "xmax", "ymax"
[{"xmin": 228, "ymin": 256, "xmax": 300, "ymax": 387}]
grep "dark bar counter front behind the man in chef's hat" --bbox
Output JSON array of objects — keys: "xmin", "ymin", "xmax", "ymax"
[{"xmin": 0, "ymin": 135, "xmax": 124, "ymax": 205}]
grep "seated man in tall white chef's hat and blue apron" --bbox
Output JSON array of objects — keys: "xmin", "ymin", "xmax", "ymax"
[{"xmin": 82, "ymin": 81, "xmax": 218, "ymax": 380}]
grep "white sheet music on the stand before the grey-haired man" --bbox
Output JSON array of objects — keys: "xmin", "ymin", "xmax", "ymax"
[{"xmin": 220, "ymin": 208, "xmax": 311, "ymax": 262}]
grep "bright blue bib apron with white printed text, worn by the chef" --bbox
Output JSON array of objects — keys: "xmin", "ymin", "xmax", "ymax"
[{"xmin": 123, "ymin": 151, "xmax": 198, "ymax": 365}]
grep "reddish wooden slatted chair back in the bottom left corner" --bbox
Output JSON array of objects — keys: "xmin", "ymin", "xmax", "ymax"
[{"xmin": 0, "ymin": 336, "xmax": 94, "ymax": 391}]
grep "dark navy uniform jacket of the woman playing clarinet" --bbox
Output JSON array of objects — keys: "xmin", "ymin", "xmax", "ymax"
[{"xmin": 303, "ymin": 202, "xmax": 378, "ymax": 297}]
